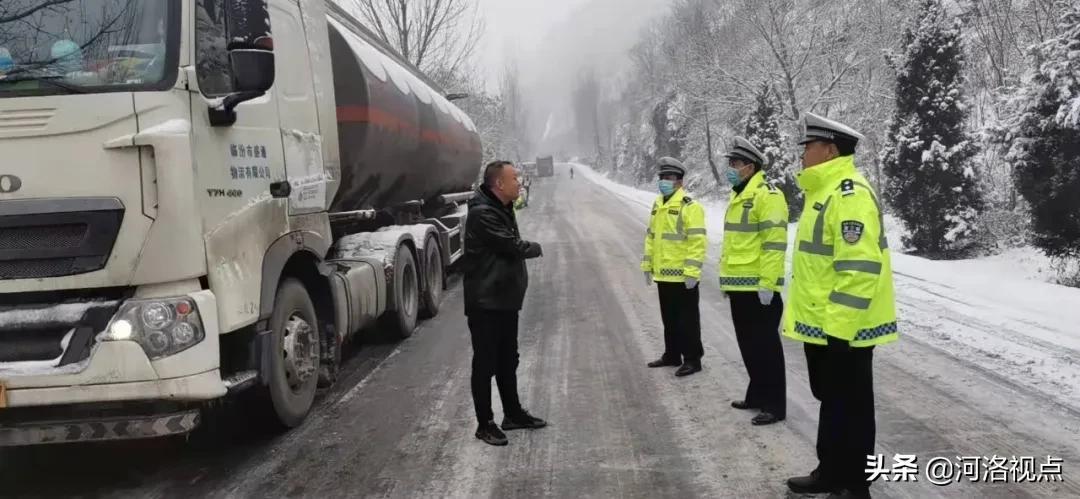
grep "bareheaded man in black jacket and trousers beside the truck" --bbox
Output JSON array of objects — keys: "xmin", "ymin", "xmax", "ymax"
[{"xmin": 463, "ymin": 161, "xmax": 548, "ymax": 445}]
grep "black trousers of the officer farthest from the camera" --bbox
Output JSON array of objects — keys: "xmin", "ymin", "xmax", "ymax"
[{"xmin": 657, "ymin": 282, "xmax": 705, "ymax": 362}]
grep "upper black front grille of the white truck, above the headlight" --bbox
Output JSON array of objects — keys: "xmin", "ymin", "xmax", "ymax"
[{"xmin": 0, "ymin": 198, "xmax": 124, "ymax": 280}]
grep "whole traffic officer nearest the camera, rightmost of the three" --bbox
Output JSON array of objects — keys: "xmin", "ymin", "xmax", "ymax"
[{"xmin": 784, "ymin": 113, "xmax": 897, "ymax": 498}]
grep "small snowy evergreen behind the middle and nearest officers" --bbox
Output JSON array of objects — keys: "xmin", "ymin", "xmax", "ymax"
[{"xmin": 745, "ymin": 84, "xmax": 802, "ymax": 221}]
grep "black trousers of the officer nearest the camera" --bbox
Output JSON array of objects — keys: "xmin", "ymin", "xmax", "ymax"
[{"xmin": 806, "ymin": 343, "xmax": 876, "ymax": 489}]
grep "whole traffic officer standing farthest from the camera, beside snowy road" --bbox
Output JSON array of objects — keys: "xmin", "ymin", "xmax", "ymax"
[{"xmin": 642, "ymin": 158, "xmax": 706, "ymax": 376}]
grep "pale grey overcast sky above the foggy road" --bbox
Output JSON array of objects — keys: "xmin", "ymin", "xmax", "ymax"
[{"xmin": 477, "ymin": 0, "xmax": 671, "ymax": 144}]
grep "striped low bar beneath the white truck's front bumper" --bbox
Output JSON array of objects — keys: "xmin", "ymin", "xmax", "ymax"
[{"xmin": 0, "ymin": 409, "xmax": 200, "ymax": 447}]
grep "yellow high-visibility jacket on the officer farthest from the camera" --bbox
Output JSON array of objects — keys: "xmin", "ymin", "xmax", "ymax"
[{"xmin": 642, "ymin": 189, "xmax": 707, "ymax": 282}]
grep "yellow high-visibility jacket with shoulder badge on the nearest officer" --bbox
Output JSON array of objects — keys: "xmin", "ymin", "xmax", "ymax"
[{"xmin": 784, "ymin": 156, "xmax": 899, "ymax": 347}]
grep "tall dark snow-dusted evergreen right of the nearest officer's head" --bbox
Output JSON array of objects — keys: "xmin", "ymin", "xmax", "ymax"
[{"xmin": 882, "ymin": 0, "xmax": 984, "ymax": 258}]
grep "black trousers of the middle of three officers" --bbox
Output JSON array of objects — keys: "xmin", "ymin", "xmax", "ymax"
[{"xmin": 728, "ymin": 292, "xmax": 787, "ymax": 418}]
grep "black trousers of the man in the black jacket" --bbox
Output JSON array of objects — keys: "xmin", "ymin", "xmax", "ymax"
[{"xmin": 469, "ymin": 310, "xmax": 522, "ymax": 424}]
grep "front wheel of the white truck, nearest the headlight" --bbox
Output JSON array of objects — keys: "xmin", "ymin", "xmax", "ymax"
[{"xmin": 261, "ymin": 278, "xmax": 320, "ymax": 430}]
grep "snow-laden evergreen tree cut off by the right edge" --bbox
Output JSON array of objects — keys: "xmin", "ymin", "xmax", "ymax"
[{"xmin": 1003, "ymin": 2, "xmax": 1080, "ymax": 260}]
